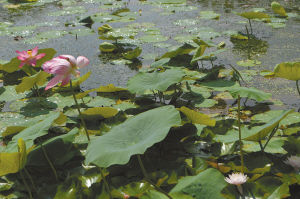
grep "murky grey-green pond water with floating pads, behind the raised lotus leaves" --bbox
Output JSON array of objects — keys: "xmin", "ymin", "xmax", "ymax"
[{"xmin": 0, "ymin": 0, "xmax": 300, "ymax": 107}]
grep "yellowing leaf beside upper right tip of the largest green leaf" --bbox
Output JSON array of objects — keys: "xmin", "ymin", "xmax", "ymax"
[{"xmin": 178, "ymin": 106, "xmax": 216, "ymax": 126}]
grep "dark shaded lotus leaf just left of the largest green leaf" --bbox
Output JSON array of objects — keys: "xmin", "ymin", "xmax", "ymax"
[{"xmin": 27, "ymin": 128, "xmax": 78, "ymax": 166}]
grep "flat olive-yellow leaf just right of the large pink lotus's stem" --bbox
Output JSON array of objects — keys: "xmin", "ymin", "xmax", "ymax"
[{"xmin": 82, "ymin": 107, "xmax": 118, "ymax": 118}]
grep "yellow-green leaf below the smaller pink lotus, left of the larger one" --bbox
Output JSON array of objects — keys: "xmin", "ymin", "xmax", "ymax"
[{"xmin": 16, "ymin": 70, "xmax": 50, "ymax": 93}]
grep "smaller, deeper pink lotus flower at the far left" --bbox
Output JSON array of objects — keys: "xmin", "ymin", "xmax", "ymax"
[{"xmin": 16, "ymin": 46, "xmax": 46, "ymax": 68}]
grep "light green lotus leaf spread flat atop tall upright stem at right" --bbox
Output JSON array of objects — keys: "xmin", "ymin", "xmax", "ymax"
[{"xmin": 228, "ymin": 87, "xmax": 271, "ymax": 102}]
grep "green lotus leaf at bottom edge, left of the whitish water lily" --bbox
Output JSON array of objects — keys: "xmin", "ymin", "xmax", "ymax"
[{"xmin": 170, "ymin": 168, "xmax": 227, "ymax": 199}]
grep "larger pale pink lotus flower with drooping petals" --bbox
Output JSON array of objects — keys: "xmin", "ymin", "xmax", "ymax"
[{"xmin": 43, "ymin": 55, "xmax": 89, "ymax": 90}]
